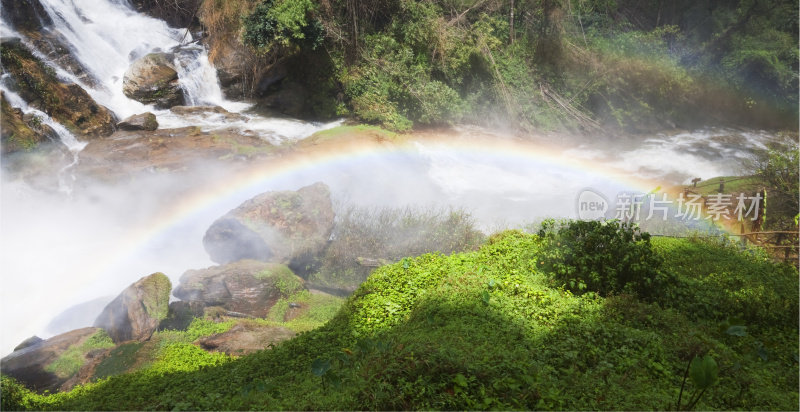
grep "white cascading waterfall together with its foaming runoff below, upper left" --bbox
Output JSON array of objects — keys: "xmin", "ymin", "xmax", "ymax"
[{"xmin": 2, "ymin": 0, "xmax": 340, "ymax": 143}]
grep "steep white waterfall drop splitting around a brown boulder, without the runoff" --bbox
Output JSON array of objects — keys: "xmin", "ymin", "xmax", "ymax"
[{"xmin": 28, "ymin": 0, "xmax": 224, "ymax": 118}]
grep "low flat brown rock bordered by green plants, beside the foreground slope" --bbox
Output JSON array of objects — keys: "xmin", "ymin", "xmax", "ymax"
[{"xmin": 195, "ymin": 322, "xmax": 295, "ymax": 356}]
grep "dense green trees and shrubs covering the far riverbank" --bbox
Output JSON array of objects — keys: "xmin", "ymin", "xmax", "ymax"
[{"xmin": 201, "ymin": 0, "xmax": 798, "ymax": 132}]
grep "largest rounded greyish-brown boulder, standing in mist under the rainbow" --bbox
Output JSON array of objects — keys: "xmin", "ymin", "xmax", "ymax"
[{"xmin": 203, "ymin": 182, "xmax": 334, "ymax": 271}]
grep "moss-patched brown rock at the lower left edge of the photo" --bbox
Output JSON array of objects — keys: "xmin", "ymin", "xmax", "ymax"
[{"xmin": 0, "ymin": 328, "xmax": 112, "ymax": 392}]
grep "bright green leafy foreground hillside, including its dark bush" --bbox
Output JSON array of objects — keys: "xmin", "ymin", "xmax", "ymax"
[{"xmin": 2, "ymin": 224, "xmax": 798, "ymax": 410}]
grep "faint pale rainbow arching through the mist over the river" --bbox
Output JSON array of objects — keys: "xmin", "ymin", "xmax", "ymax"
[{"xmin": 70, "ymin": 136, "xmax": 724, "ymax": 296}]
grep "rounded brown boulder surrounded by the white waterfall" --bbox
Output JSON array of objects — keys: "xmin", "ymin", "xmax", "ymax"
[{"xmin": 122, "ymin": 53, "xmax": 184, "ymax": 109}]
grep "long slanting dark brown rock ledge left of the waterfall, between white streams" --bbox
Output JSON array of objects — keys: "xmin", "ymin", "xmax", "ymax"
[{"xmin": 0, "ymin": 38, "xmax": 116, "ymax": 138}]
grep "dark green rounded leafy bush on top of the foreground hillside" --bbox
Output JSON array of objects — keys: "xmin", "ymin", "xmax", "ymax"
[{"xmin": 539, "ymin": 220, "xmax": 667, "ymax": 298}]
